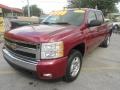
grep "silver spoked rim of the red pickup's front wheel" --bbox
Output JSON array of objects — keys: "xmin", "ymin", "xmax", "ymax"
[{"xmin": 70, "ymin": 57, "xmax": 81, "ymax": 77}]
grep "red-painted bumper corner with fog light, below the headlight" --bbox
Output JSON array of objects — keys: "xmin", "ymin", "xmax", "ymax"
[{"xmin": 37, "ymin": 57, "xmax": 67, "ymax": 79}]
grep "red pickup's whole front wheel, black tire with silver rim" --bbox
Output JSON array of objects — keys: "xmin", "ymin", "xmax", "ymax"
[{"xmin": 64, "ymin": 50, "xmax": 82, "ymax": 82}]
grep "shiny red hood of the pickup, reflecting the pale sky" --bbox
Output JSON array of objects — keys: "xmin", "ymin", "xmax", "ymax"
[{"xmin": 5, "ymin": 25, "xmax": 76, "ymax": 43}]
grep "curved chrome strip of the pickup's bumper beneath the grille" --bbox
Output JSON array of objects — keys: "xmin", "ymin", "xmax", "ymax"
[{"xmin": 3, "ymin": 48, "xmax": 37, "ymax": 71}]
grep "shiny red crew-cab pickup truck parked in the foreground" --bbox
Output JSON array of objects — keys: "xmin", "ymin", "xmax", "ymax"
[{"xmin": 3, "ymin": 9, "xmax": 111, "ymax": 81}]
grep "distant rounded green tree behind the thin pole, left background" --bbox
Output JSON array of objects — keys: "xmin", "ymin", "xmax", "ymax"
[{"xmin": 23, "ymin": 5, "xmax": 42, "ymax": 16}]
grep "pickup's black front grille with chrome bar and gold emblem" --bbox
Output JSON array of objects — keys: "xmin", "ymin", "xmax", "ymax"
[{"xmin": 5, "ymin": 39, "xmax": 40, "ymax": 61}]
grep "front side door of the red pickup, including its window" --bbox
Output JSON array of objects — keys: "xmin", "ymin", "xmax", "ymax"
[{"xmin": 86, "ymin": 11, "xmax": 99, "ymax": 53}]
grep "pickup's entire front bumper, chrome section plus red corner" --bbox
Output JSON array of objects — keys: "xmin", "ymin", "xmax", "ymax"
[{"xmin": 3, "ymin": 48, "xmax": 67, "ymax": 79}]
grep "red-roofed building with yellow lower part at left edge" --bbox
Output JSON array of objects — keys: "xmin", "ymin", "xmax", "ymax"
[{"xmin": 0, "ymin": 4, "xmax": 23, "ymax": 33}]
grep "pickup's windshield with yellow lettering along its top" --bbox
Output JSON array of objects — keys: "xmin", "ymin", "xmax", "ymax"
[{"xmin": 42, "ymin": 10, "xmax": 84, "ymax": 26}]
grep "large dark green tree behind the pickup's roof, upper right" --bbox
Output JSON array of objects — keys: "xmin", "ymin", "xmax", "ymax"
[{"xmin": 69, "ymin": 0, "xmax": 120, "ymax": 15}]
